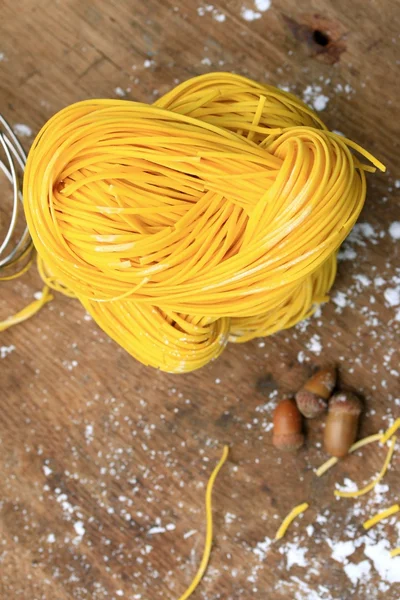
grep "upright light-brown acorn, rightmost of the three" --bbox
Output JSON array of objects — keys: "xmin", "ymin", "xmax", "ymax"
[{"xmin": 324, "ymin": 392, "xmax": 362, "ymax": 458}]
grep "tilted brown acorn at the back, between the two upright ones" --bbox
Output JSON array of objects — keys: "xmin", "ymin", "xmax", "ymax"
[{"xmin": 296, "ymin": 367, "xmax": 336, "ymax": 419}]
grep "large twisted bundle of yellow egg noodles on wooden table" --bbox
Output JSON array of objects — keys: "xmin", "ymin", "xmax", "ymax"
[{"xmin": 20, "ymin": 73, "xmax": 384, "ymax": 372}]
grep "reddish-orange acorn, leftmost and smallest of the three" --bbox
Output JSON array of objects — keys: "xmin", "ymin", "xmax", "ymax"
[{"xmin": 272, "ymin": 399, "xmax": 304, "ymax": 452}]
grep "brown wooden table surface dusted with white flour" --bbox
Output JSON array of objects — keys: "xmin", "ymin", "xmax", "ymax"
[{"xmin": 0, "ymin": 0, "xmax": 400, "ymax": 600}]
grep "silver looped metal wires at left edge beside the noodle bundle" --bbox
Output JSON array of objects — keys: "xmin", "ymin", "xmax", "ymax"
[{"xmin": 0, "ymin": 114, "xmax": 33, "ymax": 272}]
